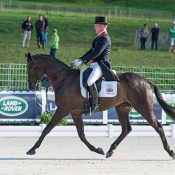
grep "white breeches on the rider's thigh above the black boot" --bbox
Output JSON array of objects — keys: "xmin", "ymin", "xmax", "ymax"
[{"xmin": 87, "ymin": 62, "xmax": 102, "ymax": 86}]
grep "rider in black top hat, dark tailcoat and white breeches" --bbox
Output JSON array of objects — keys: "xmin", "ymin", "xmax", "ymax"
[{"xmin": 71, "ymin": 16, "xmax": 117, "ymax": 113}]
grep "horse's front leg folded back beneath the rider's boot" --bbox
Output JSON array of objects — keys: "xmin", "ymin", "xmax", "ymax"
[{"xmin": 72, "ymin": 114, "xmax": 105, "ymax": 155}]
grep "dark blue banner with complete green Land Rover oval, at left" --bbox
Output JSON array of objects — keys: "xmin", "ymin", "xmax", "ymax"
[{"xmin": 0, "ymin": 91, "xmax": 41, "ymax": 121}]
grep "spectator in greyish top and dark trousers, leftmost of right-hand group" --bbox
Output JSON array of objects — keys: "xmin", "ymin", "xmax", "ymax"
[{"xmin": 140, "ymin": 24, "xmax": 149, "ymax": 50}]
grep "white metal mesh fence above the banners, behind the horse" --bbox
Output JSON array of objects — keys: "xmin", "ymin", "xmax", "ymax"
[{"xmin": 0, "ymin": 63, "xmax": 175, "ymax": 93}]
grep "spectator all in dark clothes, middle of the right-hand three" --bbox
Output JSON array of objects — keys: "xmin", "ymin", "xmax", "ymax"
[{"xmin": 151, "ymin": 23, "xmax": 159, "ymax": 51}]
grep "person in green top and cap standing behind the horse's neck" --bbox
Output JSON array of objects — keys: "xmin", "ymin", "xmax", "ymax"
[{"xmin": 48, "ymin": 29, "xmax": 59, "ymax": 58}]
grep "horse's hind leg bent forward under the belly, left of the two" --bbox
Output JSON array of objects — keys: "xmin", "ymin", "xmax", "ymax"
[{"xmin": 106, "ymin": 105, "xmax": 132, "ymax": 158}]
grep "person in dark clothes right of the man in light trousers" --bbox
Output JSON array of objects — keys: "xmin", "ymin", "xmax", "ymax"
[{"xmin": 35, "ymin": 15, "xmax": 44, "ymax": 49}]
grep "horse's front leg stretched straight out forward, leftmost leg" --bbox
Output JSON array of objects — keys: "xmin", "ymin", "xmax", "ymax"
[{"xmin": 26, "ymin": 108, "xmax": 67, "ymax": 155}]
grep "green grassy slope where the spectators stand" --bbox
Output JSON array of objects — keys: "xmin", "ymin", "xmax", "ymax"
[{"xmin": 0, "ymin": 7, "xmax": 175, "ymax": 68}]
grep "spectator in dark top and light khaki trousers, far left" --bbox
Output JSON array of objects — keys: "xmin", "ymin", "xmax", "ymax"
[{"xmin": 21, "ymin": 16, "xmax": 33, "ymax": 48}]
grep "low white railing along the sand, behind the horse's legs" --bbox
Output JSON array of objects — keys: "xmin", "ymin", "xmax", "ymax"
[{"xmin": 0, "ymin": 124, "xmax": 175, "ymax": 138}]
